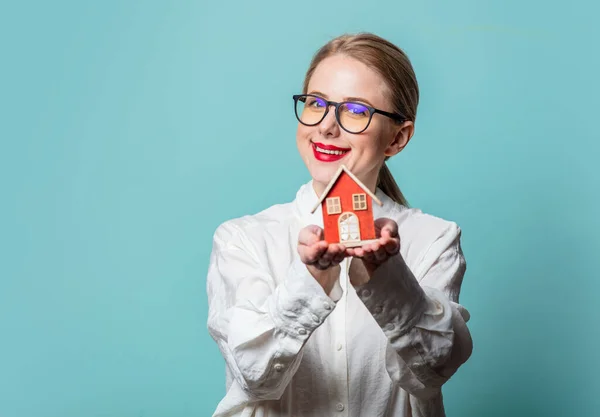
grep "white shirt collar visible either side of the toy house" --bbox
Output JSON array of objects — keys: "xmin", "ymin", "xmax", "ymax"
[{"xmin": 295, "ymin": 180, "xmax": 398, "ymax": 227}]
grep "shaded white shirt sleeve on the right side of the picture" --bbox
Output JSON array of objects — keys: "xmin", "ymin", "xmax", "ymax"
[{"xmin": 356, "ymin": 223, "xmax": 473, "ymax": 398}]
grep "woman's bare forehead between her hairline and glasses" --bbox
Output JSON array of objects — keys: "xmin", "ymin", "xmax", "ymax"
[{"xmin": 308, "ymin": 55, "xmax": 388, "ymax": 107}]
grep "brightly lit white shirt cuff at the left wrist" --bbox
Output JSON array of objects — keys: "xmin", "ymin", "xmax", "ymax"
[{"xmin": 271, "ymin": 258, "xmax": 341, "ymax": 339}]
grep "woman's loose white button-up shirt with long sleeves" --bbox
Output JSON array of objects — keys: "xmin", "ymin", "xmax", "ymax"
[{"xmin": 207, "ymin": 182, "xmax": 472, "ymax": 417}]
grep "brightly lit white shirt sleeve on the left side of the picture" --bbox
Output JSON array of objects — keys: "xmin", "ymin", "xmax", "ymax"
[{"xmin": 207, "ymin": 223, "xmax": 340, "ymax": 400}]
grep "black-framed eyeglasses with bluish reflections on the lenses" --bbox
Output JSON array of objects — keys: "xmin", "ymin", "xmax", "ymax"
[{"xmin": 293, "ymin": 94, "xmax": 407, "ymax": 134}]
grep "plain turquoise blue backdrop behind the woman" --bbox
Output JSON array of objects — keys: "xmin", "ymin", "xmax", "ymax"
[{"xmin": 0, "ymin": 0, "xmax": 600, "ymax": 417}]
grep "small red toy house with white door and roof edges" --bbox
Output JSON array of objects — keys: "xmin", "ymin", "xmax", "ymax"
[{"xmin": 312, "ymin": 165, "xmax": 383, "ymax": 247}]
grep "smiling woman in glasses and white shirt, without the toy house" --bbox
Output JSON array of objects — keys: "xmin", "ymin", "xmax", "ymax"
[{"xmin": 207, "ymin": 34, "xmax": 472, "ymax": 417}]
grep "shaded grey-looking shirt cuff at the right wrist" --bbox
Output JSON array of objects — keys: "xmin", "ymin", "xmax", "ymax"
[{"xmin": 356, "ymin": 254, "xmax": 429, "ymax": 337}]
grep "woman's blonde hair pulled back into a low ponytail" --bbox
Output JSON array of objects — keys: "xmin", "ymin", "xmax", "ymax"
[{"xmin": 303, "ymin": 33, "xmax": 419, "ymax": 207}]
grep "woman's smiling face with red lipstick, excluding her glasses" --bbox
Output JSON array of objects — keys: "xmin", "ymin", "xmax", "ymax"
[{"xmin": 296, "ymin": 55, "xmax": 413, "ymax": 194}]
